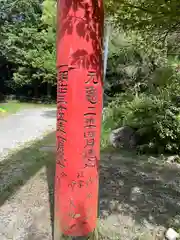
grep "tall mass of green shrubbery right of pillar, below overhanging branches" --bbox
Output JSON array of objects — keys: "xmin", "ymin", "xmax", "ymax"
[{"xmin": 102, "ymin": 32, "xmax": 180, "ymax": 153}]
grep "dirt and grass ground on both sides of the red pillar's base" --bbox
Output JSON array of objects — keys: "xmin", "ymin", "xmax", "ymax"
[{"xmin": 0, "ymin": 134, "xmax": 180, "ymax": 240}]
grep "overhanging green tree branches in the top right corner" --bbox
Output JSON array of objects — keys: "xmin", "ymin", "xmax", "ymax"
[{"xmin": 105, "ymin": 0, "xmax": 180, "ymax": 37}]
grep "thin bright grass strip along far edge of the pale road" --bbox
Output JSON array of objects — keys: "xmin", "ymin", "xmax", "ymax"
[{"xmin": 0, "ymin": 101, "xmax": 56, "ymax": 117}]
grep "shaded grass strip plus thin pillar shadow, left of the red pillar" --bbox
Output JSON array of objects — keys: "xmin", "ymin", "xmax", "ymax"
[{"xmin": 0, "ymin": 132, "xmax": 55, "ymax": 239}]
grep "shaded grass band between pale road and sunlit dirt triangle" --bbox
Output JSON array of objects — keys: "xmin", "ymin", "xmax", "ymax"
[{"xmin": 0, "ymin": 133, "xmax": 55, "ymax": 206}]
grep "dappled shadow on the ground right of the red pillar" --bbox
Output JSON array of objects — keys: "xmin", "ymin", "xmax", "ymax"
[{"xmin": 100, "ymin": 150, "xmax": 180, "ymax": 227}]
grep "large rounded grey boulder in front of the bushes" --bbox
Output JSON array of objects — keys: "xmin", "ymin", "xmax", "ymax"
[{"xmin": 109, "ymin": 126, "xmax": 138, "ymax": 148}]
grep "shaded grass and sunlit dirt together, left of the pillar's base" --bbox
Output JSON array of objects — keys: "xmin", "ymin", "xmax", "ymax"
[{"xmin": 0, "ymin": 133, "xmax": 55, "ymax": 240}]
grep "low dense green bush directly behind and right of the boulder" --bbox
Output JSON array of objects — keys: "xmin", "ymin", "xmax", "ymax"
[{"xmin": 103, "ymin": 81, "xmax": 180, "ymax": 153}]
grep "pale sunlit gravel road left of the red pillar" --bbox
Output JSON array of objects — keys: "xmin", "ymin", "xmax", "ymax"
[{"xmin": 0, "ymin": 108, "xmax": 56, "ymax": 161}]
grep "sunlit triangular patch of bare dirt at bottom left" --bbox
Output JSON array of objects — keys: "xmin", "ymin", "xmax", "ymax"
[{"xmin": 0, "ymin": 167, "xmax": 52, "ymax": 240}]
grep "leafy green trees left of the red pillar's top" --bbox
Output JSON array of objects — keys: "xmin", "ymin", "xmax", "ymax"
[{"xmin": 0, "ymin": 0, "xmax": 56, "ymax": 92}]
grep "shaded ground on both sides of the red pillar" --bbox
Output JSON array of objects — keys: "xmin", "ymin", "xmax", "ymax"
[{"xmin": 0, "ymin": 133, "xmax": 180, "ymax": 238}]
